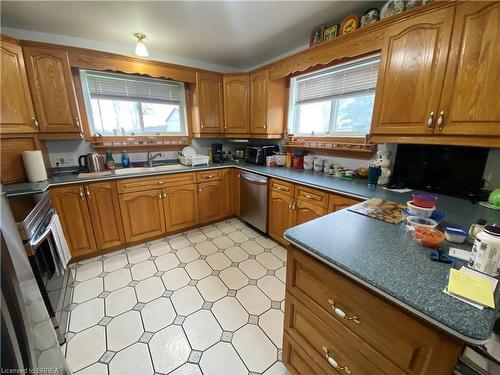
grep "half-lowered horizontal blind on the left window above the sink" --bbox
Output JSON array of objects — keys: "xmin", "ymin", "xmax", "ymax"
[{"xmin": 84, "ymin": 71, "xmax": 184, "ymax": 104}]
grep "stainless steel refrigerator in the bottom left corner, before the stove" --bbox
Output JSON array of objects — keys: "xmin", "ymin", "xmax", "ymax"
[{"xmin": 0, "ymin": 194, "xmax": 71, "ymax": 374}]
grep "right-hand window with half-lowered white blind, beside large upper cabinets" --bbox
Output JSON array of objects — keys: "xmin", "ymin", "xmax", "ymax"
[{"xmin": 288, "ymin": 56, "xmax": 380, "ymax": 137}]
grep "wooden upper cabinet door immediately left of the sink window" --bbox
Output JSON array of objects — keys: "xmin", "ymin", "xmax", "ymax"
[{"xmin": 24, "ymin": 47, "xmax": 81, "ymax": 133}]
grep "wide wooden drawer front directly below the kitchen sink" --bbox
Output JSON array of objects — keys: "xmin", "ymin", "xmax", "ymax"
[{"xmin": 116, "ymin": 173, "xmax": 195, "ymax": 194}]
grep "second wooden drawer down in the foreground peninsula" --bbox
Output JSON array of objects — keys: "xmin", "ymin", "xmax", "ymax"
[{"xmin": 285, "ymin": 293, "xmax": 401, "ymax": 375}]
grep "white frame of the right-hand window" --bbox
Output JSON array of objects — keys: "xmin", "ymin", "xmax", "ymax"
[{"xmin": 287, "ymin": 53, "xmax": 380, "ymax": 138}]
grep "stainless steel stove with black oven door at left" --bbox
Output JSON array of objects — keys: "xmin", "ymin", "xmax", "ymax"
[{"xmin": 10, "ymin": 192, "xmax": 74, "ymax": 344}]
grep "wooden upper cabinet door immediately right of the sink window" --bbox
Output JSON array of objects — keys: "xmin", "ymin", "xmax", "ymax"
[{"xmin": 196, "ymin": 73, "xmax": 224, "ymax": 133}]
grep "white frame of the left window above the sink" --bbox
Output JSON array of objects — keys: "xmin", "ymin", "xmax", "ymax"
[{"xmin": 80, "ymin": 69, "xmax": 189, "ymax": 137}]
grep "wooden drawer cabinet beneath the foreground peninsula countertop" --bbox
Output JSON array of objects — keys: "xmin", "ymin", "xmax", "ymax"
[{"xmin": 283, "ymin": 246, "xmax": 463, "ymax": 374}]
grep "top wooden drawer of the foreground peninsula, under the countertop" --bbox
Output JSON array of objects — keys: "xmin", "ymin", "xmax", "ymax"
[{"xmin": 286, "ymin": 247, "xmax": 462, "ymax": 374}]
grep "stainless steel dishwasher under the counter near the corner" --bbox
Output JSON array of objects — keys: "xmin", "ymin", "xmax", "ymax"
[{"xmin": 240, "ymin": 171, "xmax": 267, "ymax": 233}]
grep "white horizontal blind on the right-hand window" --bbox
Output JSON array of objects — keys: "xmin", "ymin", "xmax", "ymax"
[{"xmin": 295, "ymin": 56, "xmax": 380, "ymax": 104}]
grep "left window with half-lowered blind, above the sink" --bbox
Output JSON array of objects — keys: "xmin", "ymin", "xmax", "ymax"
[{"xmin": 80, "ymin": 70, "xmax": 187, "ymax": 136}]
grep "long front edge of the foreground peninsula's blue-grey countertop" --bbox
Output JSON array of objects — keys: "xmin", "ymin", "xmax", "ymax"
[{"xmin": 283, "ymin": 234, "xmax": 491, "ymax": 345}]
